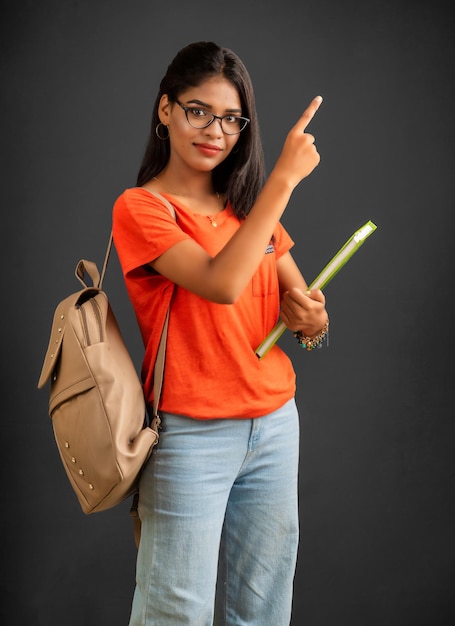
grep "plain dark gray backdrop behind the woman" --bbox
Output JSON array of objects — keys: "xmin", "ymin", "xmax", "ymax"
[{"xmin": 0, "ymin": 0, "xmax": 455, "ymax": 626}]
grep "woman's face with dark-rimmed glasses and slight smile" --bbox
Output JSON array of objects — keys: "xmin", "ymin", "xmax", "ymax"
[{"xmin": 158, "ymin": 77, "xmax": 244, "ymax": 177}]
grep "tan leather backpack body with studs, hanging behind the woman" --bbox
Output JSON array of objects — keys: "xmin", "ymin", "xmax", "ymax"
[{"xmin": 38, "ymin": 262, "xmax": 158, "ymax": 513}]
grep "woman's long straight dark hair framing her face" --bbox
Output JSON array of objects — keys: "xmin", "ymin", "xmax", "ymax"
[{"xmin": 136, "ymin": 41, "xmax": 265, "ymax": 218}]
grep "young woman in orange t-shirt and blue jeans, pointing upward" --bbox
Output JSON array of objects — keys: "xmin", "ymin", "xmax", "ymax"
[{"xmin": 113, "ymin": 42, "xmax": 328, "ymax": 626}]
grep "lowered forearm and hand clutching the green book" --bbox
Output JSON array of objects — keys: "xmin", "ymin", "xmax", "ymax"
[{"xmin": 277, "ymin": 252, "xmax": 328, "ymax": 337}]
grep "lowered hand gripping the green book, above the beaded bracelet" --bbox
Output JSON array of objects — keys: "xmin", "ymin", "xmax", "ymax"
[{"xmin": 280, "ymin": 287, "xmax": 328, "ymax": 337}]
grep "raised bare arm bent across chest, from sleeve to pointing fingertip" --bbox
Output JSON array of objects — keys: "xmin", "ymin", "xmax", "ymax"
[{"xmin": 152, "ymin": 97, "xmax": 322, "ymax": 304}]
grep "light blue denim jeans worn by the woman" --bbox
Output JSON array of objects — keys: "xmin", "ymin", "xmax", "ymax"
[{"xmin": 130, "ymin": 400, "xmax": 299, "ymax": 626}]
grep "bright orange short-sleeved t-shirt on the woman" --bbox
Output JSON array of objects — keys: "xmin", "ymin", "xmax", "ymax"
[{"xmin": 113, "ymin": 187, "xmax": 295, "ymax": 419}]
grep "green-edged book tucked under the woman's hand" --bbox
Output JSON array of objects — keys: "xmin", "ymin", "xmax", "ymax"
[{"xmin": 256, "ymin": 222, "xmax": 377, "ymax": 359}]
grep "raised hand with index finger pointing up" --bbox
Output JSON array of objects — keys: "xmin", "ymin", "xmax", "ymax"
[{"xmin": 272, "ymin": 96, "xmax": 322, "ymax": 190}]
